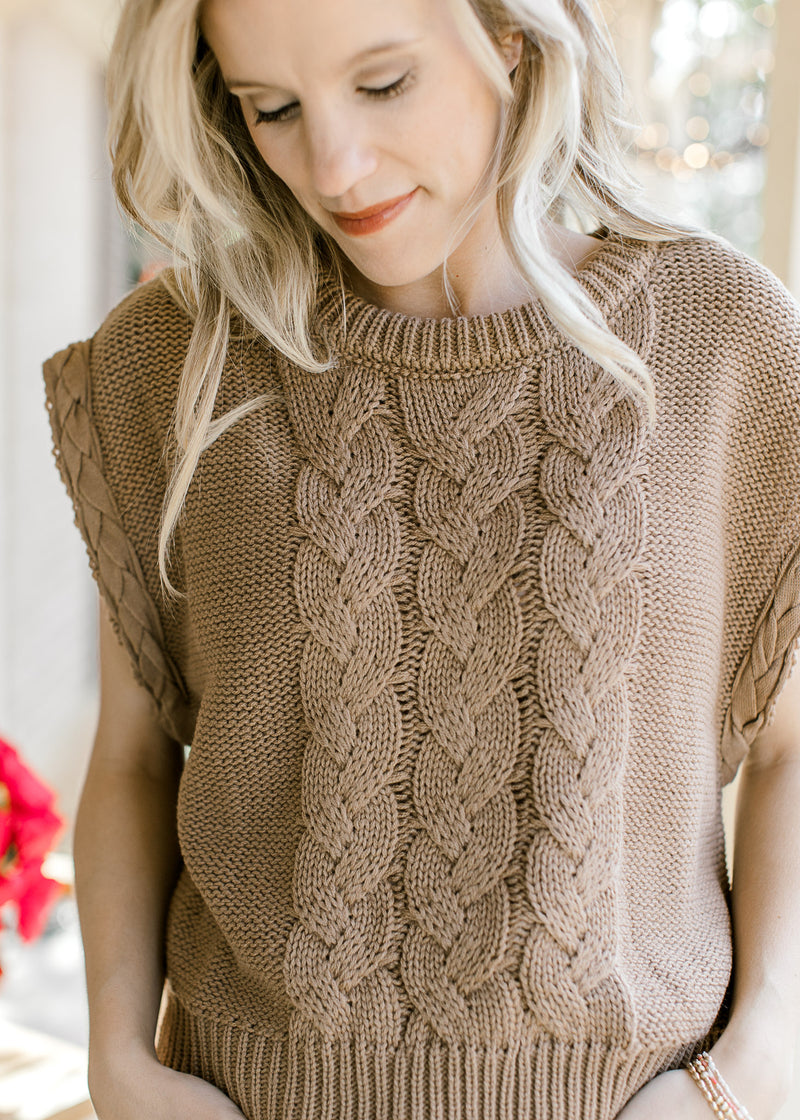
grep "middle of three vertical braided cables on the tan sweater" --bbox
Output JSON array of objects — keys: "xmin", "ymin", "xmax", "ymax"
[{"xmin": 400, "ymin": 368, "xmax": 527, "ymax": 1046}]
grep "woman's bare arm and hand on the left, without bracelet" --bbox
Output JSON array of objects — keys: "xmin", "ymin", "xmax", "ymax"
[{"xmin": 80, "ymin": 599, "xmax": 246, "ymax": 1120}]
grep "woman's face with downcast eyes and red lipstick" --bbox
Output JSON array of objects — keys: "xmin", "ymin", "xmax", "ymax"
[{"xmin": 202, "ymin": 0, "xmax": 520, "ymax": 304}]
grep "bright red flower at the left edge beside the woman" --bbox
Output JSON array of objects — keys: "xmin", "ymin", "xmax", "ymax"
[{"xmin": 0, "ymin": 739, "xmax": 64, "ymax": 941}]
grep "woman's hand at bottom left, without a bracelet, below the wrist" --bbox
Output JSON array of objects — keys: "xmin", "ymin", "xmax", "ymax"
[{"xmin": 89, "ymin": 1039, "xmax": 244, "ymax": 1120}]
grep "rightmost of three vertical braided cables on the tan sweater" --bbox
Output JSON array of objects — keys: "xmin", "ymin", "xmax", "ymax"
[{"xmin": 521, "ymin": 342, "xmax": 645, "ymax": 1045}]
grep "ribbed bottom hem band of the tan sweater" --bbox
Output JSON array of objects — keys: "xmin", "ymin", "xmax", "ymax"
[{"xmin": 158, "ymin": 989, "xmax": 705, "ymax": 1120}]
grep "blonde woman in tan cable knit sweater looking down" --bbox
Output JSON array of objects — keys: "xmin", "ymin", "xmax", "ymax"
[{"xmin": 40, "ymin": 0, "xmax": 800, "ymax": 1120}]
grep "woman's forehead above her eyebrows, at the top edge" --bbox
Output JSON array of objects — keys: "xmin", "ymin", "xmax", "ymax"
[{"xmin": 199, "ymin": 0, "xmax": 436, "ymax": 85}]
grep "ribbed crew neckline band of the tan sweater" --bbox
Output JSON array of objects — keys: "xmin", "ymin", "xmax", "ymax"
[{"xmin": 316, "ymin": 232, "xmax": 661, "ymax": 375}]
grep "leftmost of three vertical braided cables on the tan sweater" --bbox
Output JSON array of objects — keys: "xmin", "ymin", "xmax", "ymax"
[{"xmin": 277, "ymin": 353, "xmax": 402, "ymax": 1043}]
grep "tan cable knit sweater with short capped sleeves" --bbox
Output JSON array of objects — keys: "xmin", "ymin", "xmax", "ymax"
[{"xmin": 45, "ymin": 229, "xmax": 800, "ymax": 1120}]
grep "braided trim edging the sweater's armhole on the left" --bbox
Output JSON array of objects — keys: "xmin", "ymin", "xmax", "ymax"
[{"xmin": 44, "ymin": 297, "xmax": 192, "ymax": 743}]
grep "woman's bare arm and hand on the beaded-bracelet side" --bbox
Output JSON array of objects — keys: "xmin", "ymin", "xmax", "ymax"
[{"xmin": 617, "ymin": 660, "xmax": 800, "ymax": 1120}]
